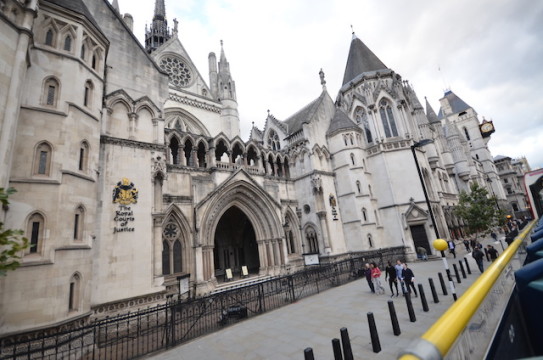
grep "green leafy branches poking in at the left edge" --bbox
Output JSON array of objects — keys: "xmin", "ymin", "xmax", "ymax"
[{"xmin": 0, "ymin": 188, "xmax": 28, "ymax": 276}]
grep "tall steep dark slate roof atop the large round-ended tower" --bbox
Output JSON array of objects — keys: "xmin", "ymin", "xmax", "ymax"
[{"xmin": 343, "ymin": 35, "xmax": 388, "ymax": 85}]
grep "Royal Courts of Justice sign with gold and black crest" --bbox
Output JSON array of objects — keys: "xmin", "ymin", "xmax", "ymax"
[{"xmin": 113, "ymin": 178, "xmax": 138, "ymax": 234}]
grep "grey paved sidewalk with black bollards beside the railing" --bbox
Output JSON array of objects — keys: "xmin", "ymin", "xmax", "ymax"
[{"xmin": 148, "ymin": 240, "xmax": 502, "ymax": 360}]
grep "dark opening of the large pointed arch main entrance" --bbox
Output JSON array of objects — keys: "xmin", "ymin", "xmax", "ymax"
[{"xmin": 213, "ymin": 206, "xmax": 260, "ymax": 281}]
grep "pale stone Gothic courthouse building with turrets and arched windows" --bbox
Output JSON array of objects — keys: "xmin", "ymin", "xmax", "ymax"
[{"xmin": 0, "ymin": 0, "xmax": 505, "ymax": 334}]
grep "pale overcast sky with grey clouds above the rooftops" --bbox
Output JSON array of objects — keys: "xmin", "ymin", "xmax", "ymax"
[{"xmin": 118, "ymin": 0, "xmax": 543, "ymax": 169}]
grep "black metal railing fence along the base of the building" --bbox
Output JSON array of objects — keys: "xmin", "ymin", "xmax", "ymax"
[{"xmin": 0, "ymin": 247, "xmax": 405, "ymax": 360}]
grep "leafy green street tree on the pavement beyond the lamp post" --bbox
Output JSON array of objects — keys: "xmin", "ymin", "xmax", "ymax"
[{"xmin": 454, "ymin": 183, "xmax": 505, "ymax": 238}]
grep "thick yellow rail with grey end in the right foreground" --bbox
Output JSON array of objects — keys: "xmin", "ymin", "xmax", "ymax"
[{"xmin": 398, "ymin": 221, "xmax": 536, "ymax": 360}]
